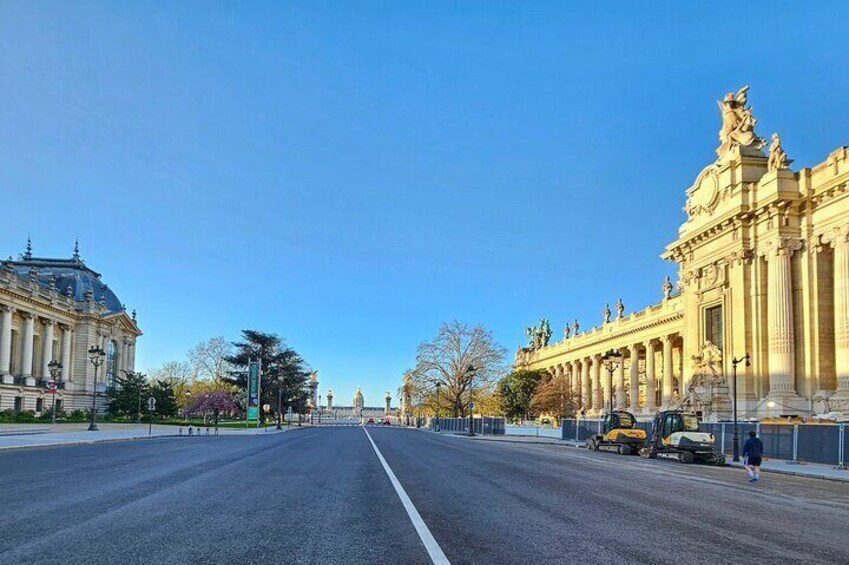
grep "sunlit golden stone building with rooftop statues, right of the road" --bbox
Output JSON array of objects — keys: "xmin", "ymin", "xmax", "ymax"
[{"xmin": 516, "ymin": 87, "xmax": 849, "ymax": 418}]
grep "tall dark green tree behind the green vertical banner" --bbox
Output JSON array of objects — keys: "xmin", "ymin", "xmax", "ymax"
[{"xmin": 224, "ymin": 330, "xmax": 309, "ymax": 414}]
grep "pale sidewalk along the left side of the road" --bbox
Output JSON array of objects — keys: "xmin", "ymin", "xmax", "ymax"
[{"xmin": 0, "ymin": 423, "xmax": 289, "ymax": 451}]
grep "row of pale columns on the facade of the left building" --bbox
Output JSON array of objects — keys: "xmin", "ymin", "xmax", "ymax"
[{"xmin": 0, "ymin": 305, "xmax": 71, "ymax": 382}]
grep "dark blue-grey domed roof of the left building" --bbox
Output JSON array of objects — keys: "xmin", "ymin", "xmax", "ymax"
[{"xmin": 6, "ymin": 253, "xmax": 124, "ymax": 313}]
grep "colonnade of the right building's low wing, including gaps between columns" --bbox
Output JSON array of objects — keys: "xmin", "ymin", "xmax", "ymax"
[{"xmin": 548, "ymin": 334, "xmax": 681, "ymax": 414}]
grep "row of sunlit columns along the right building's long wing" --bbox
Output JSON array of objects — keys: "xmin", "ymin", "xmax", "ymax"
[{"xmin": 551, "ymin": 335, "xmax": 675, "ymax": 413}]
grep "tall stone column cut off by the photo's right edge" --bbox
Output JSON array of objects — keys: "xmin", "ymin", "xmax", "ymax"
[{"xmin": 828, "ymin": 225, "xmax": 849, "ymax": 406}]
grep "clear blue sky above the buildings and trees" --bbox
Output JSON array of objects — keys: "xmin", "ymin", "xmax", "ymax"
[{"xmin": 0, "ymin": 0, "xmax": 849, "ymax": 404}]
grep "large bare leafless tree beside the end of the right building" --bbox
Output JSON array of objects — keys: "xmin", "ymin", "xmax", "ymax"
[{"xmin": 411, "ymin": 320, "xmax": 507, "ymax": 416}]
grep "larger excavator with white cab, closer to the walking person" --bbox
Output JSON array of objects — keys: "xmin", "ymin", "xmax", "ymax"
[{"xmin": 640, "ymin": 410, "xmax": 725, "ymax": 465}]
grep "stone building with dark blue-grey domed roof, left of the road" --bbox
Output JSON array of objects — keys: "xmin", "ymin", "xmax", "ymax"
[{"xmin": 0, "ymin": 241, "xmax": 141, "ymax": 413}]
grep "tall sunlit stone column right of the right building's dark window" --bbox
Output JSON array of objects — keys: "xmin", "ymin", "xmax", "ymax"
[{"xmin": 764, "ymin": 237, "xmax": 802, "ymax": 400}]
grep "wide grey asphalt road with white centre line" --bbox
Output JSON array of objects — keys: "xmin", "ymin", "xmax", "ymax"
[{"xmin": 0, "ymin": 426, "xmax": 849, "ymax": 565}]
